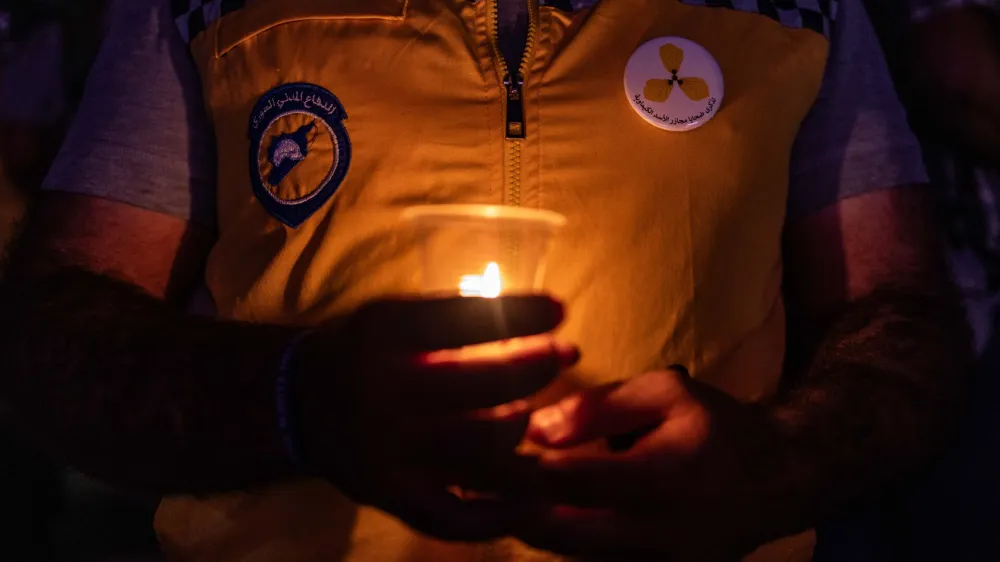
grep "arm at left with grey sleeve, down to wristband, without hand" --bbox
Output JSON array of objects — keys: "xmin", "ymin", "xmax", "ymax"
[{"xmin": 0, "ymin": 0, "xmax": 320, "ymax": 492}]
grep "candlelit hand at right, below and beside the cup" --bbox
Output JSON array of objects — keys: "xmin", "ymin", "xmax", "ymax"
[{"xmin": 508, "ymin": 370, "xmax": 777, "ymax": 562}]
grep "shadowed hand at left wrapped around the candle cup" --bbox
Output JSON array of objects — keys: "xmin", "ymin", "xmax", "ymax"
[{"xmin": 296, "ymin": 296, "xmax": 579, "ymax": 541}]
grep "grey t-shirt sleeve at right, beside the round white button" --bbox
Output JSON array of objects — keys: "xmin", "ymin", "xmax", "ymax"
[{"xmin": 788, "ymin": 0, "xmax": 927, "ymax": 218}]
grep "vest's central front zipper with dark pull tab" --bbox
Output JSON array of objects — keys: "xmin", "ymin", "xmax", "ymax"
[{"xmin": 490, "ymin": 0, "xmax": 538, "ymax": 206}]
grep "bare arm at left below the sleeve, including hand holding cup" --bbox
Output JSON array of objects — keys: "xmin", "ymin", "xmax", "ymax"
[{"xmin": 0, "ymin": 194, "xmax": 572, "ymax": 493}]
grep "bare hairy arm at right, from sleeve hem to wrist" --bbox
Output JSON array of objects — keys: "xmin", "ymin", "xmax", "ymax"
[{"xmin": 770, "ymin": 187, "xmax": 971, "ymax": 531}]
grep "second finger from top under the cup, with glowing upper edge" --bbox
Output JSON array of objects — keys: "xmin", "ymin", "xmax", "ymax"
[{"xmin": 397, "ymin": 336, "xmax": 580, "ymax": 406}]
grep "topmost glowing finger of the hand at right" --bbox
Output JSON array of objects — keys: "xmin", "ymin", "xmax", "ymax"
[{"xmin": 528, "ymin": 372, "xmax": 686, "ymax": 447}]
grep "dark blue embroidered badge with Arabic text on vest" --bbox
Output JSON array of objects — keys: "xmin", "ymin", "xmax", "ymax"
[{"xmin": 249, "ymin": 83, "xmax": 351, "ymax": 228}]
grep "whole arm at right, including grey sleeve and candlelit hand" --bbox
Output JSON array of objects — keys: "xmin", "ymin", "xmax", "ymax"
[{"xmin": 498, "ymin": 1, "xmax": 970, "ymax": 560}]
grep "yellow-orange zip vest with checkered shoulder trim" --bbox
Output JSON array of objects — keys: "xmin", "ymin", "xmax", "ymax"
[{"xmin": 156, "ymin": 0, "xmax": 830, "ymax": 562}]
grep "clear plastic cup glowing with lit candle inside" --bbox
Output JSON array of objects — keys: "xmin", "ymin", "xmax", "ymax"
[{"xmin": 403, "ymin": 205, "xmax": 566, "ymax": 298}]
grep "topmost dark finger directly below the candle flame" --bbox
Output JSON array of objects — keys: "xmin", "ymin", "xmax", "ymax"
[{"xmin": 355, "ymin": 295, "xmax": 563, "ymax": 351}]
